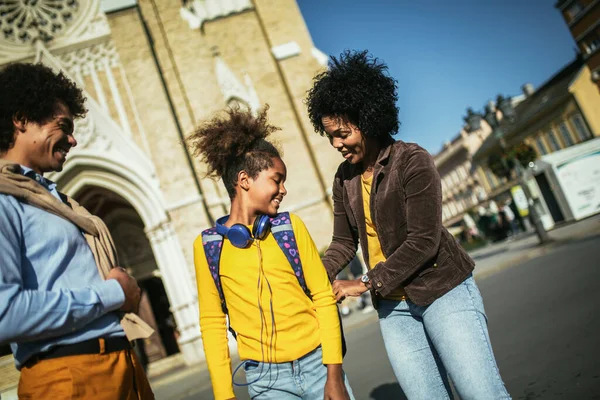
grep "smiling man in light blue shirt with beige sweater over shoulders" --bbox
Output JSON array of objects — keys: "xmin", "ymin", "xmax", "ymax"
[{"xmin": 0, "ymin": 64, "xmax": 154, "ymax": 400}]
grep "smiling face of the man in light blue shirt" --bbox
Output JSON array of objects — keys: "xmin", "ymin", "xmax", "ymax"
[{"xmin": 14, "ymin": 102, "xmax": 77, "ymax": 174}]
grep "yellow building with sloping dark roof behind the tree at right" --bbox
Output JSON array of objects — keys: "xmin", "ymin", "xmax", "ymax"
[{"xmin": 473, "ymin": 57, "xmax": 600, "ymax": 231}]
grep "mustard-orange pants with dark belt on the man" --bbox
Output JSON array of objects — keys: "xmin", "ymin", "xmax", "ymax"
[{"xmin": 18, "ymin": 342, "xmax": 154, "ymax": 400}]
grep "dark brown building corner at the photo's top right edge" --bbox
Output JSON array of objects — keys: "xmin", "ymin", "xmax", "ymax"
[{"xmin": 556, "ymin": 0, "xmax": 600, "ymax": 89}]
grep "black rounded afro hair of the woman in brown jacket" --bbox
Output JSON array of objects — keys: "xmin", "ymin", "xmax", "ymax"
[{"xmin": 305, "ymin": 50, "xmax": 400, "ymax": 142}]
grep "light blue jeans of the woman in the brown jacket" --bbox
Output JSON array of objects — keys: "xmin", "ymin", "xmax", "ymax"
[{"xmin": 377, "ymin": 276, "xmax": 510, "ymax": 400}]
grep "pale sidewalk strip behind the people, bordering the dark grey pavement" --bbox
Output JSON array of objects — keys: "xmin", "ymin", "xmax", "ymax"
[{"xmin": 149, "ymin": 215, "xmax": 600, "ymax": 392}]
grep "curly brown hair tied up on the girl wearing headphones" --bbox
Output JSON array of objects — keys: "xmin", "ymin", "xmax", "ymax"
[{"xmin": 187, "ymin": 106, "xmax": 281, "ymax": 199}]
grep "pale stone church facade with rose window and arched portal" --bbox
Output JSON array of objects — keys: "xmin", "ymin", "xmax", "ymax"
[{"xmin": 0, "ymin": 0, "xmax": 341, "ymax": 370}]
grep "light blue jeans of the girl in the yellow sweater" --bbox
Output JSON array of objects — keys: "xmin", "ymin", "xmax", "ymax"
[{"xmin": 244, "ymin": 347, "xmax": 354, "ymax": 400}]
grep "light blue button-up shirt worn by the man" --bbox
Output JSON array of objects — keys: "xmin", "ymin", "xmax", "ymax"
[{"xmin": 0, "ymin": 167, "xmax": 125, "ymax": 369}]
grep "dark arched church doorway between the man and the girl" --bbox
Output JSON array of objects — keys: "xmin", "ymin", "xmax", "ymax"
[{"xmin": 75, "ymin": 186, "xmax": 179, "ymax": 364}]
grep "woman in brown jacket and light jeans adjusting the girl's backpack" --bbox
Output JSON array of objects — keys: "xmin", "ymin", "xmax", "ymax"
[{"xmin": 306, "ymin": 51, "xmax": 510, "ymax": 399}]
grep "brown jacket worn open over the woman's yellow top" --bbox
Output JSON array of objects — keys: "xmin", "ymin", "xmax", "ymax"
[{"xmin": 323, "ymin": 141, "xmax": 475, "ymax": 306}]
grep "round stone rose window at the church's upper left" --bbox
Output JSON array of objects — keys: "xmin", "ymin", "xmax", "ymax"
[{"xmin": 0, "ymin": 0, "xmax": 80, "ymax": 44}]
